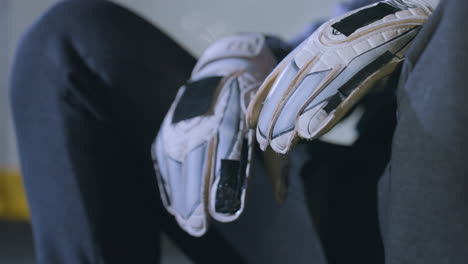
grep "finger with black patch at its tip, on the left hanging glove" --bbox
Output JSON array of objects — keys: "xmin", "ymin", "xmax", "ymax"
[{"xmin": 209, "ymin": 78, "xmax": 249, "ymax": 222}]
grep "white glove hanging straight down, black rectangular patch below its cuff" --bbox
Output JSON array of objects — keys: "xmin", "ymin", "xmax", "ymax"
[{"xmin": 152, "ymin": 34, "xmax": 277, "ymax": 236}]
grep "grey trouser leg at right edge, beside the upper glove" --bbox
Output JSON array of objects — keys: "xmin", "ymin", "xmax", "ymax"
[{"xmin": 381, "ymin": 1, "xmax": 468, "ymax": 263}]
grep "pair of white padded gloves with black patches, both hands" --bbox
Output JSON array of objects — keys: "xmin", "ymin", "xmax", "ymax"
[{"xmin": 152, "ymin": 0, "xmax": 438, "ymax": 236}]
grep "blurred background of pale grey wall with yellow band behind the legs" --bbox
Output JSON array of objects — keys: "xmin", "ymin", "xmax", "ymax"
[{"xmin": 0, "ymin": 0, "xmax": 339, "ymax": 264}]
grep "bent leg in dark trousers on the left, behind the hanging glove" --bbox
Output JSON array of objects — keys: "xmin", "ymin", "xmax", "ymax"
[{"xmin": 11, "ymin": 0, "xmax": 241, "ymax": 263}]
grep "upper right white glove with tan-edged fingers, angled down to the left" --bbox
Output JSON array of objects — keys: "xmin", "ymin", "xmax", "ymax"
[{"xmin": 246, "ymin": 0, "xmax": 438, "ymax": 154}]
